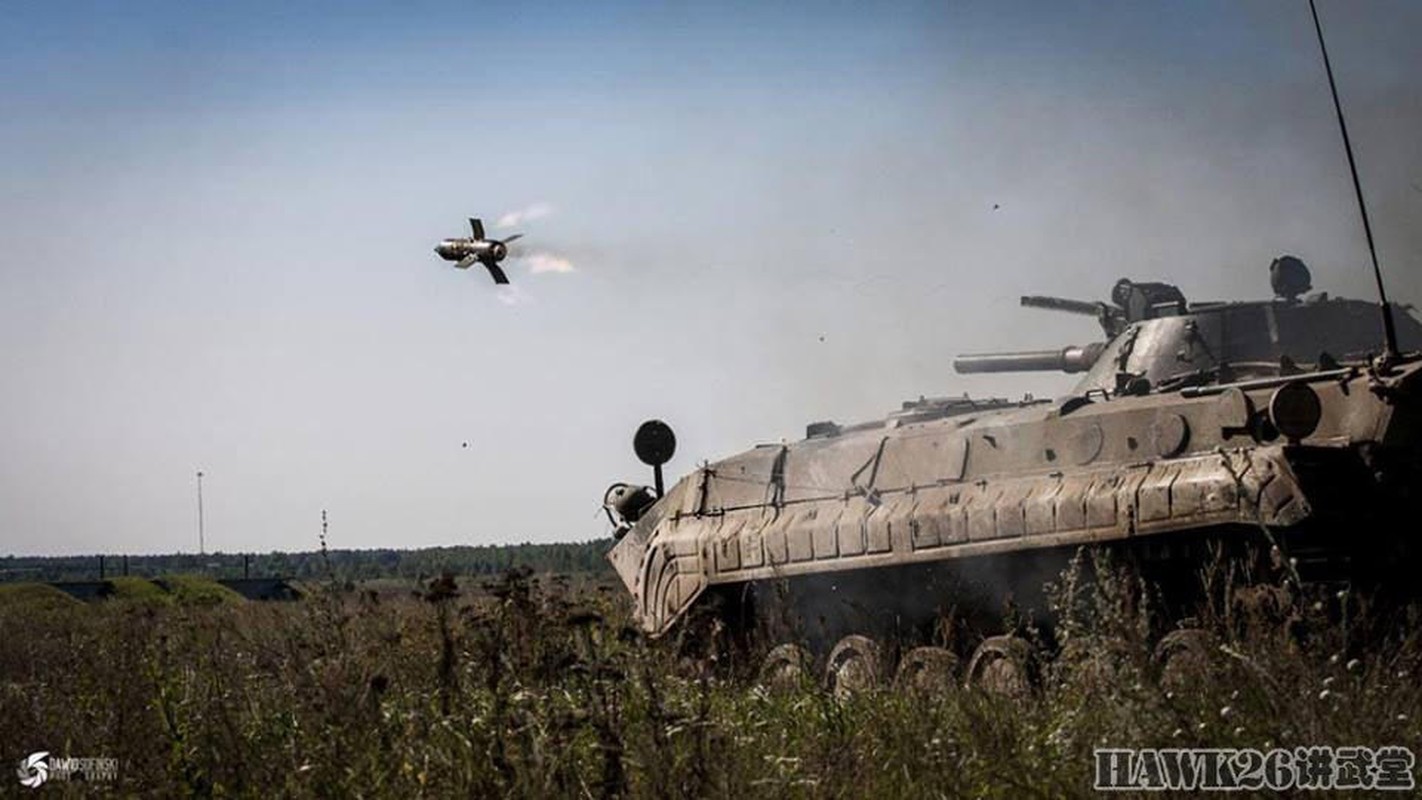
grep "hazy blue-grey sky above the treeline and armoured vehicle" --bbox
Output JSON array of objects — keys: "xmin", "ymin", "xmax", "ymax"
[{"xmin": 0, "ymin": 1, "xmax": 1422, "ymax": 554}]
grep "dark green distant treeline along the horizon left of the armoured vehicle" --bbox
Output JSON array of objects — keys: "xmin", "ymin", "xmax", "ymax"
[{"xmin": 0, "ymin": 539, "xmax": 611, "ymax": 583}]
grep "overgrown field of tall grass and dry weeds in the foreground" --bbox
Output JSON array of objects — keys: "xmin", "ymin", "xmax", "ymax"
[{"xmin": 0, "ymin": 559, "xmax": 1422, "ymax": 797}]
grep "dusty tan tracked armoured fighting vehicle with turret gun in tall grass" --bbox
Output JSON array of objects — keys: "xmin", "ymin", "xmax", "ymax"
[{"xmin": 604, "ymin": 256, "xmax": 1422, "ymax": 682}]
